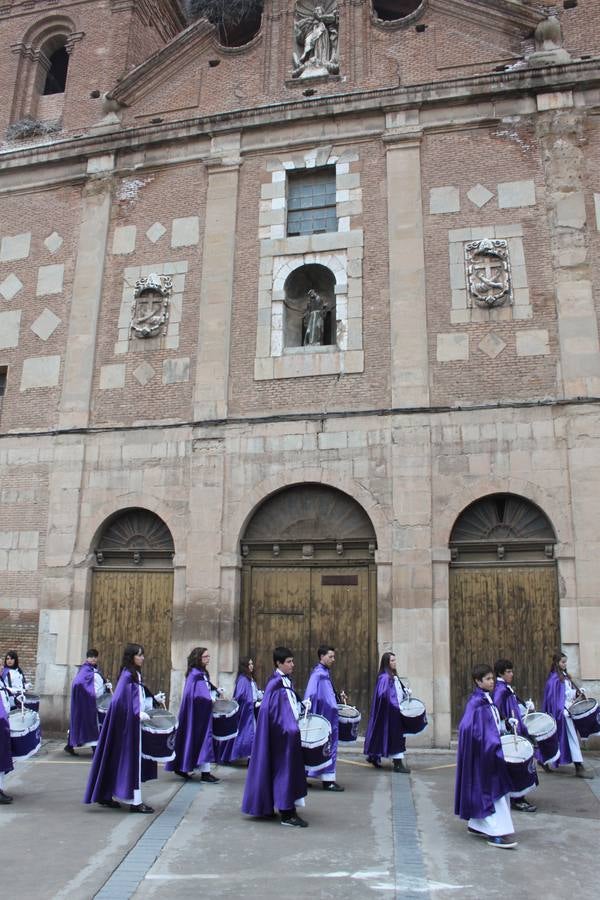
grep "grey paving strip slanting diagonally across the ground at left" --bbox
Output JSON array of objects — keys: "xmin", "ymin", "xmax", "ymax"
[{"xmin": 95, "ymin": 781, "xmax": 200, "ymax": 900}]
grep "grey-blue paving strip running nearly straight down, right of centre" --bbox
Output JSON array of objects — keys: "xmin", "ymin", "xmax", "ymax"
[{"xmin": 391, "ymin": 774, "xmax": 429, "ymax": 900}]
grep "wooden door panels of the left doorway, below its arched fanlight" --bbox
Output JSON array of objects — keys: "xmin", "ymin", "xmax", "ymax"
[{"xmin": 89, "ymin": 570, "xmax": 173, "ymax": 695}]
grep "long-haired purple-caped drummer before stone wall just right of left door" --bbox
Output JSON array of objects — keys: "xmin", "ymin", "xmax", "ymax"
[{"xmin": 165, "ymin": 647, "xmax": 220, "ymax": 784}]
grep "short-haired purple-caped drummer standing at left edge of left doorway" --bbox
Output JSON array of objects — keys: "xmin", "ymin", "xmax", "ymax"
[{"xmin": 64, "ymin": 647, "xmax": 112, "ymax": 756}]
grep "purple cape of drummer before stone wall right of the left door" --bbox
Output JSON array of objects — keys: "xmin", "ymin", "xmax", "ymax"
[{"xmin": 165, "ymin": 669, "xmax": 215, "ymax": 772}]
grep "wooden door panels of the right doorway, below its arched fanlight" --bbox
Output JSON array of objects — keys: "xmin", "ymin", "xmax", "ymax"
[{"xmin": 449, "ymin": 565, "xmax": 560, "ymax": 727}]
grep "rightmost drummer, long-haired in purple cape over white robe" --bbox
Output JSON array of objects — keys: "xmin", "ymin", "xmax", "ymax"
[{"xmin": 542, "ymin": 652, "xmax": 594, "ymax": 778}]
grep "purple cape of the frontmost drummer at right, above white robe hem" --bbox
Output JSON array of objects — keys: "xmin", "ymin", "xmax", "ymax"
[{"xmin": 454, "ymin": 688, "xmax": 512, "ymax": 819}]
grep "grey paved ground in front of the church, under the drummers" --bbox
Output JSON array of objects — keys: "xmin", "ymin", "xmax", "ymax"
[{"xmin": 0, "ymin": 742, "xmax": 600, "ymax": 900}]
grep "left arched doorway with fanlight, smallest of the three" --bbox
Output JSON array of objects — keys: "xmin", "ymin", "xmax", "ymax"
[{"xmin": 89, "ymin": 509, "xmax": 174, "ymax": 694}]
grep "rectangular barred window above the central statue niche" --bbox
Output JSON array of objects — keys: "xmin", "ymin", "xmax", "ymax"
[{"xmin": 287, "ymin": 166, "xmax": 338, "ymax": 237}]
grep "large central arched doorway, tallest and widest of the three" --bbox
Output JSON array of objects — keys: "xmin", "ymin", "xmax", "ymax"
[{"xmin": 240, "ymin": 484, "xmax": 377, "ymax": 714}]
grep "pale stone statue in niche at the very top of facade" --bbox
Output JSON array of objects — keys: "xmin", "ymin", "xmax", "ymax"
[{"xmin": 292, "ymin": 0, "xmax": 340, "ymax": 78}]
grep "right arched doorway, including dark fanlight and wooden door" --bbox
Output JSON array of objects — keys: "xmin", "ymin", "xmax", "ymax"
[{"xmin": 449, "ymin": 494, "xmax": 560, "ymax": 727}]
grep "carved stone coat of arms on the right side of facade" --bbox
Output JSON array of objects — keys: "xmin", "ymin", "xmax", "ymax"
[{"xmin": 465, "ymin": 238, "xmax": 512, "ymax": 307}]
